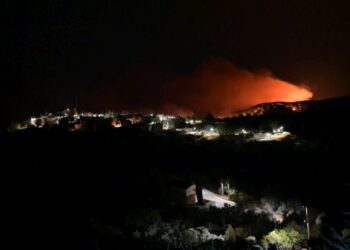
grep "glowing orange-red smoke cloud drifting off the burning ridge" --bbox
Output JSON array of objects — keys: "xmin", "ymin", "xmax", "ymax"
[{"xmin": 158, "ymin": 60, "xmax": 313, "ymax": 116}]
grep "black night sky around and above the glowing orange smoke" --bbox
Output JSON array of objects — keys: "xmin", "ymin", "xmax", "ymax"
[{"xmin": 1, "ymin": 0, "xmax": 350, "ymax": 120}]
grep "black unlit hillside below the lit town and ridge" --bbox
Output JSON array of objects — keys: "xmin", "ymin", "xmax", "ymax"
[{"xmin": 1, "ymin": 98, "xmax": 350, "ymax": 249}]
